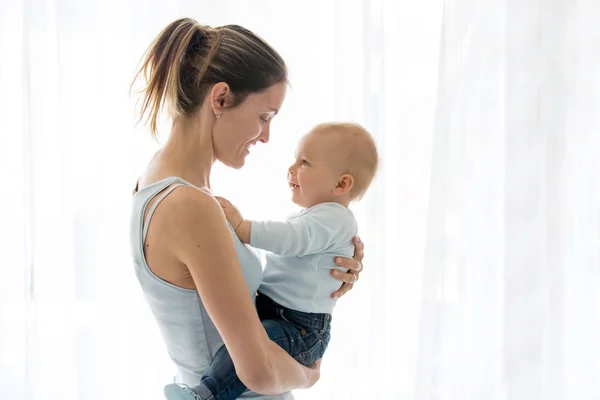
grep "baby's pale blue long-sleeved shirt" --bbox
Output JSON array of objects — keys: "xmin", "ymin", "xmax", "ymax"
[{"xmin": 250, "ymin": 203, "xmax": 358, "ymax": 314}]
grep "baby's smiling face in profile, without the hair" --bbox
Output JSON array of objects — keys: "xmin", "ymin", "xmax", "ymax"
[{"xmin": 288, "ymin": 132, "xmax": 341, "ymax": 208}]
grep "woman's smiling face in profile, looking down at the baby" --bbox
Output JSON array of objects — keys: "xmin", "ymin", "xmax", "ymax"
[{"xmin": 213, "ymin": 82, "xmax": 287, "ymax": 169}]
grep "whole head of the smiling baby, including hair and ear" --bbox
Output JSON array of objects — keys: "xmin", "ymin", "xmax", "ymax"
[{"xmin": 288, "ymin": 122, "xmax": 379, "ymax": 208}]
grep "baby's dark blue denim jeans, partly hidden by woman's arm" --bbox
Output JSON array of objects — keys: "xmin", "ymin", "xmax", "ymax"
[{"xmin": 193, "ymin": 293, "xmax": 331, "ymax": 400}]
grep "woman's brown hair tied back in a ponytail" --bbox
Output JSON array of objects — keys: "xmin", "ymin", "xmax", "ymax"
[{"xmin": 132, "ymin": 18, "xmax": 287, "ymax": 137}]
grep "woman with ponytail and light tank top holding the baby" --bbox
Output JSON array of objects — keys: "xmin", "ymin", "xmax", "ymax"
[{"xmin": 130, "ymin": 19, "xmax": 363, "ymax": 399}]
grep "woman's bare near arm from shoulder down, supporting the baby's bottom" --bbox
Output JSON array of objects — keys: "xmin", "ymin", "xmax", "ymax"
[{"xmin": 161, "ymin": 187, "xmax": 319, "ymax": 394}]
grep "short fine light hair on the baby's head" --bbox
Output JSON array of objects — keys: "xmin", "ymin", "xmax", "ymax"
[{"xmin": 312, "ymin": 122, "xmax": 379, "ymax": 201}]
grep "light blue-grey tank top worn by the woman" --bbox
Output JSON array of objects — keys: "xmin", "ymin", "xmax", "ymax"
[{"xmin": 130, "ymin": 177, "xmax": 294, "ymax": 400}]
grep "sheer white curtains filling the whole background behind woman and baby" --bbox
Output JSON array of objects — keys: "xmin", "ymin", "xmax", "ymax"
[{"xmin": 0, "ymin": 0, "xmax": 600, "ymax": 400}]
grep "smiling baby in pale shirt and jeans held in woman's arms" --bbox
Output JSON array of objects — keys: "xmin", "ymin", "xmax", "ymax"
[{"xmin": 165, "ymin": 123, "xmax": 379, "ymax": 400}]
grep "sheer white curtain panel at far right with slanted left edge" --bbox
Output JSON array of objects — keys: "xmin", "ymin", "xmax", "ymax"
[{"xmin": 416, "ymin": 0, "xmax": 600, "ymax": 400}]
